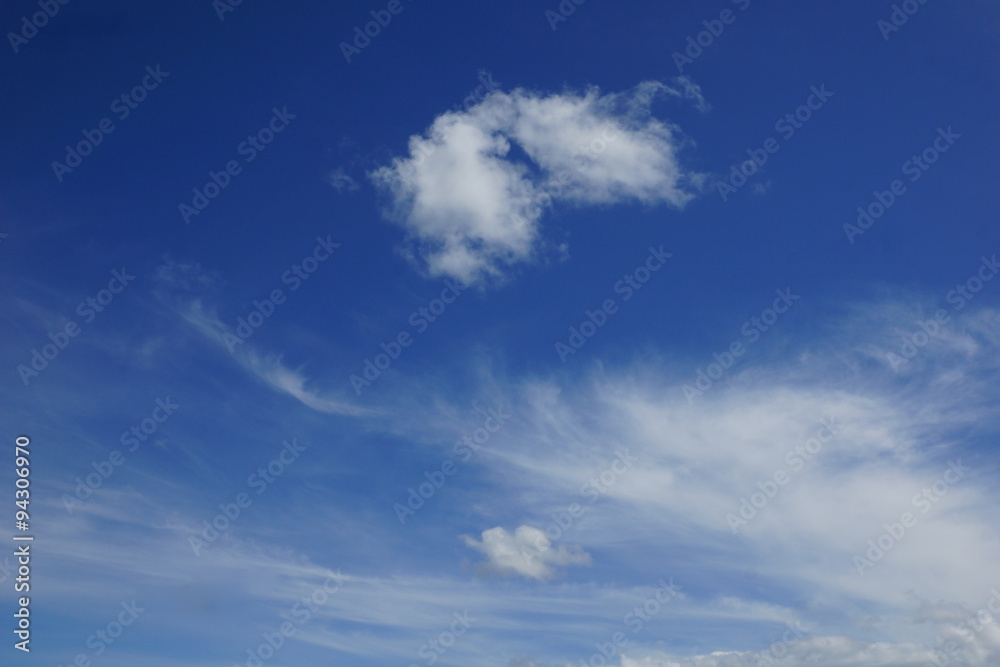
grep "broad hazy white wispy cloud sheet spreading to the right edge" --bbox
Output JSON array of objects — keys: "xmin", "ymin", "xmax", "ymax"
[{"xmin": 494, "ymin": 358, "xmax": 1000, "ymax": 610}]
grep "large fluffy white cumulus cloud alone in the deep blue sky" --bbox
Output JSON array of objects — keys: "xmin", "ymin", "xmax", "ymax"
[{"xmin": 371, "ymin": 80, "xmax": 704, "ymax": 283}]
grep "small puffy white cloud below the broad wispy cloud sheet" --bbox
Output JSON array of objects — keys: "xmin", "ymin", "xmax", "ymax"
[{"xmin": 463, "ymin": 526, "xmax": 590, "ymax": 580}]
